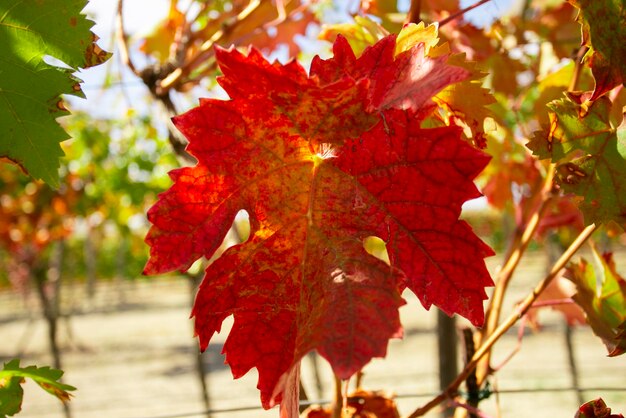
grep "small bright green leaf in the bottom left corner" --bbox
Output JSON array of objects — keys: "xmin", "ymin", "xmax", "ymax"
[{"xmin": 0, "ymin": 359, "xmax": 76, "ymax": 418}]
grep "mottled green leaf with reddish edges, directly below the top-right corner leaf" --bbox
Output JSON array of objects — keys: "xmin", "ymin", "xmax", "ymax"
[{"xmin": 527, "ymin": 93, "xmax": 626, "ymax": 226}]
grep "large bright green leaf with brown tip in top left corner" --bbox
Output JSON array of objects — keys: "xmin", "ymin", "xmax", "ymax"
[{"xmin": 0, "ymin": 0, "xmax": 110, "ymax": 186}]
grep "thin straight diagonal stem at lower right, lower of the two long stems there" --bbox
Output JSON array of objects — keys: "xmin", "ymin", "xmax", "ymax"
[{"xmin": 407, "ymin": 224, "xmax": 597, "ymax": 418}]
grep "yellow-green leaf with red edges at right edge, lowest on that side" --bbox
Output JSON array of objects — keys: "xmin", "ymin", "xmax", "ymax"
[{"xmin": 568, "ymin": 248, "xmax": 626, "ymax": 357}]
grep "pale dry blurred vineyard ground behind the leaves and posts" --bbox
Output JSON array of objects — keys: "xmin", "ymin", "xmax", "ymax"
[{"xmin": 0, "ymin": 251, "xmax": 626, "ymax": 418}]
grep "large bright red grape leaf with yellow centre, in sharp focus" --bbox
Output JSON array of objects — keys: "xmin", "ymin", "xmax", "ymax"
[{"xmin": 145, "ymin": 36, "xmax": 492, "ymax": 407}]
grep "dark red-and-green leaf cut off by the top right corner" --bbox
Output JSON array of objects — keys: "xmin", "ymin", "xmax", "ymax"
[{"xmin": 568, "ymin": 0, "xmax": 626, "ymax": 100}]
